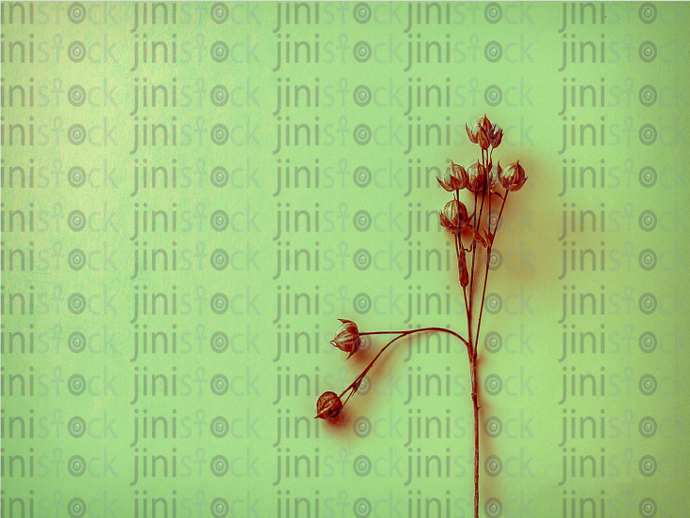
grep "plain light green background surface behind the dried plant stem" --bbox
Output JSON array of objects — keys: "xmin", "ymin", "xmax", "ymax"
[{"xmin": 2, "ymin": 2, "xmax": 690, "ymax": 518}]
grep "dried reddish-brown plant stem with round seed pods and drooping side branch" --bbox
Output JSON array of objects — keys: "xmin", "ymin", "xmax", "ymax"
[{"xmin": 316, "ymin": 115, "xmax": 527, "ymax": 518}]
